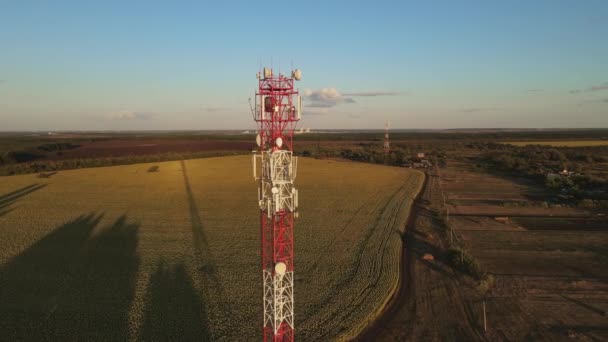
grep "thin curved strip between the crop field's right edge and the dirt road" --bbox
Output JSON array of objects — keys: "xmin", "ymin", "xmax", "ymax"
[{"xmin": 346, "ymin": 170, "xmax": 428, "ymax": 341}]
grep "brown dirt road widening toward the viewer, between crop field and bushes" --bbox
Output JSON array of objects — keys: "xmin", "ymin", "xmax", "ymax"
[{"xmin": 359, "ymin": 172, "xmax": 484, "ymax": 341}]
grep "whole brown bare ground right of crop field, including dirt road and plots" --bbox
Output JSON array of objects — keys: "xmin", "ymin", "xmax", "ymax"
[{"xmin": 359, "ymin": 158, "xmax": 608, "ymax": 341}]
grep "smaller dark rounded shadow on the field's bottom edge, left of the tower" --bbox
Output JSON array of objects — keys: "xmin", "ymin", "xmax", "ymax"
[{"xmin": 139, "ymin": 260, "xmax": 211, "ymax": 341}]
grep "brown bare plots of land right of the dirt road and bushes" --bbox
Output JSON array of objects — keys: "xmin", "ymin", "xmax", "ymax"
[{"xmin": 442, "ymin": 163, "xmax": 608, "ymax": 341}]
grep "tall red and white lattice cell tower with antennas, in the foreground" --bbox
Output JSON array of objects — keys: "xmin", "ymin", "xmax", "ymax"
[{"xmin": 253, "ymin": 68, "xmax": 302, "ymax": 341}]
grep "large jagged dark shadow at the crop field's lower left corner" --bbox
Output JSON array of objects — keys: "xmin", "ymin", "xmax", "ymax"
[{"xmin": 0, "ymin": 214, "xmax": 139, "ymax": 341}]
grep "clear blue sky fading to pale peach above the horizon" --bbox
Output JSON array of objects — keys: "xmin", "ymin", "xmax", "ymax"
[{"xmin": 0, "ymin": 0, "xmax": 608, "ymax": 131}]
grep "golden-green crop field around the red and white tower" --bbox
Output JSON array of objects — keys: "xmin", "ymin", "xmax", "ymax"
[{"xmin": 0, "ymin": 156, "xmax": 423, "ymax": 341}]
